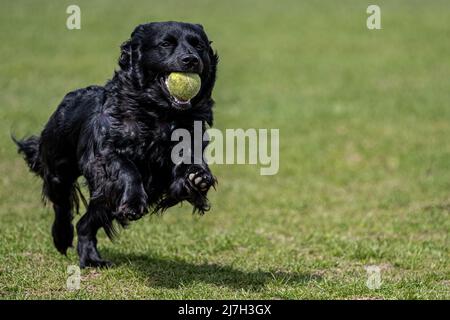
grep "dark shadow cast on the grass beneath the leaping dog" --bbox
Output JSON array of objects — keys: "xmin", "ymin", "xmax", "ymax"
[{"xmin": 104, "ymin": 250, "xmax": 321, "ymax": 290}]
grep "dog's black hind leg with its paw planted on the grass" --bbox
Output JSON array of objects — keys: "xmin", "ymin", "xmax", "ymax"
[{"xmin": 77, "ymin": 200, "xmax": 112, "ymax": 268}]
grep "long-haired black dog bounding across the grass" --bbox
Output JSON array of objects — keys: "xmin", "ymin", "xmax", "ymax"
[{"xmin": 14, "ymin": 22, "xmax": 218, "ymax": 267}]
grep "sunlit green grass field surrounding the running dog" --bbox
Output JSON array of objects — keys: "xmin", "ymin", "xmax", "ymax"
[{"xmin": 0, "ymin": 0, "xmax": 450, "ymax": 299}]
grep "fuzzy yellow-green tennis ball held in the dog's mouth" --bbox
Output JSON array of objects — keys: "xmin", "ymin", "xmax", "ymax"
[{"xmin": 166, "ymin": 72, "xmax": 202, "ymax": 101}]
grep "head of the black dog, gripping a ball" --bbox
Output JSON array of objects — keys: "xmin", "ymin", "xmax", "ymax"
[{"xmin": 119, "ymin": 21, "xmax": 218, "ymax": 110}]
